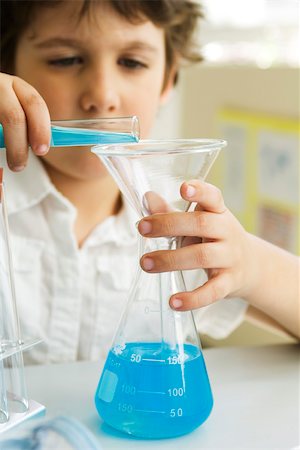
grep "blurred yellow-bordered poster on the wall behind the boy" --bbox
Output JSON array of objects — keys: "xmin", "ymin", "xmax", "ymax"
[{"xmin": 212, "ymin": 109, "xmax": 300, "ymax": 254}]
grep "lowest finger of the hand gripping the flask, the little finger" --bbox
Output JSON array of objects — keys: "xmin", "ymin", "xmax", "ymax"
[{"xmin": 169, "ymin": 271, "xmax": 231, "ymax": 311}]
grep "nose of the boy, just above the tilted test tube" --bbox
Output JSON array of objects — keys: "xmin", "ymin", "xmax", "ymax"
[{"xmin": 80, "ymin": 68, "xmax": 120, "ymax": 115}]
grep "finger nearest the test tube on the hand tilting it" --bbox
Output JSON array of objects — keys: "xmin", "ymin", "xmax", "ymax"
[{"xmin": 13, "ymin": 77, "xmax": 50, "ymax": 155}]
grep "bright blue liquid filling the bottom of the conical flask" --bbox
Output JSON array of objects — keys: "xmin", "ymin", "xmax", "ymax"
[{"xmin": 95, "ymin": 342, "xmax": 213, "ymax": 439}]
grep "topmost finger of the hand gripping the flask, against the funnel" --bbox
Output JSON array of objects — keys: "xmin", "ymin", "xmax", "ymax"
[{"xmin": 180, "ymin": 180, "xmax": 226, "ymax": 213}]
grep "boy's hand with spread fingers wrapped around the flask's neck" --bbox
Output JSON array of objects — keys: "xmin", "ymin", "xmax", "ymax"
[{"xmin": 138, "ymin": 180, "xmax": 255, "ymax": 311}]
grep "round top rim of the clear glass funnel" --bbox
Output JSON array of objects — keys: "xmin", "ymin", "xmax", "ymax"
[{"xmin": 91, "ymin": 138, "xmax": 227, "ymax": 156}]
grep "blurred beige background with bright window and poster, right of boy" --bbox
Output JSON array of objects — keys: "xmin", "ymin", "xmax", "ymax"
[{"xmin": 153, "ymin": 0, "xmax": 300, "ymax": 346}]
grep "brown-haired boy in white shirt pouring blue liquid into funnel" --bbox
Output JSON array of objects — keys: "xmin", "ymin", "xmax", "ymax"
[{"xmin": 0, "ymin": 0, "xmax": 299, "ymax": 362}]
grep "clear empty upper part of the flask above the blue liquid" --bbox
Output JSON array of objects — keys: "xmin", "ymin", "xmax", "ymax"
[{"xmin": 114, "ymin": 232, "xmax": 200, "ymax": 351}]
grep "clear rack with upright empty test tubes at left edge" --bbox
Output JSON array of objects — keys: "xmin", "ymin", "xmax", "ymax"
[{"xmin": 0, "ymin": 167, "xmax": 45, "ymax": 433}]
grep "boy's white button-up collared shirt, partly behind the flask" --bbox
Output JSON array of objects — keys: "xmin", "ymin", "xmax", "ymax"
[{"xmin": 0, "ymin": 152, "xmax": 247, "ymax": 363}]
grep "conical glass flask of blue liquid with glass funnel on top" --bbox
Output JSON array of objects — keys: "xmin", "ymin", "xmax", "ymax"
[{"xmin": 92, "ymin": 140, "xmax": 225, "ymax": 439}]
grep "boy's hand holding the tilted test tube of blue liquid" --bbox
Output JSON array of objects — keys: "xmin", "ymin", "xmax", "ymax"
[{"xmin": 0, "ymin": 73, "xmax": 50, "ymax": 172}]
